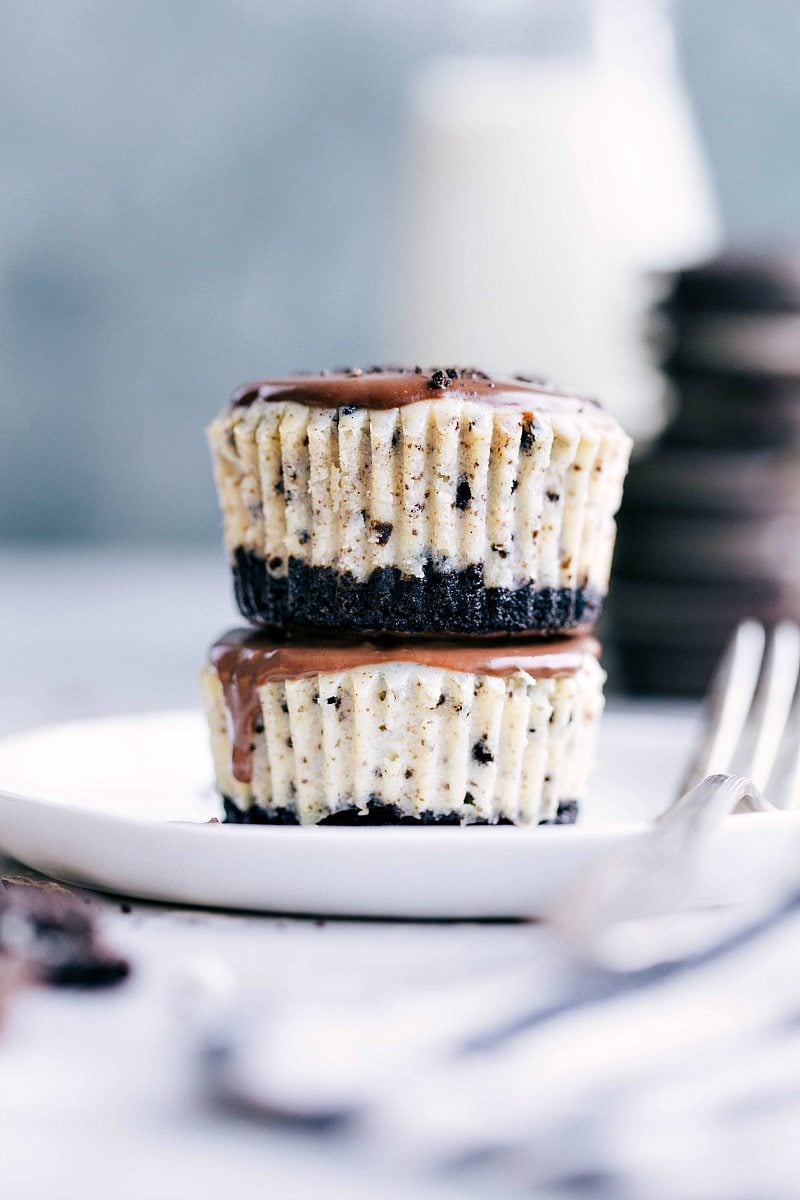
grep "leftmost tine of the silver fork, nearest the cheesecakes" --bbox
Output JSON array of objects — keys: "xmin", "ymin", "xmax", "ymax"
[{"xmin": 681, "ymin": 620, "xmax": 766, "ymax": 792}]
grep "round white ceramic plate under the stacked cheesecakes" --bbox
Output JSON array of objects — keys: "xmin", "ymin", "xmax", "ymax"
[{"xmin": 0, "ymin": 709, "xmax": 800, "ymax": 918}]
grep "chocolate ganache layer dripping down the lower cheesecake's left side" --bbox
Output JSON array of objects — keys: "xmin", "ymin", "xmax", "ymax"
[{"xmin": 210, "ymin": 629, "xmax": 600, "ymax": 784}]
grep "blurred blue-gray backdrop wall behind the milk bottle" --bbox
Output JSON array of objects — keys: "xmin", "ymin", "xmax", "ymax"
[{"xmin": 0, "ymin": 0, "xmax": 800, "ymax": 545}]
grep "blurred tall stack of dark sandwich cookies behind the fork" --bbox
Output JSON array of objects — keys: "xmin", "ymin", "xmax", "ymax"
[{"xmin": 614, "ymin": 256, "xmax": 800, "ymax": 694}]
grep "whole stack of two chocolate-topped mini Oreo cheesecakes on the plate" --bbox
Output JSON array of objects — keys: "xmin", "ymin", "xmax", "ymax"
[{"xmin": 203, "ymin": 367, "xmax": 630, "ymax": 826}]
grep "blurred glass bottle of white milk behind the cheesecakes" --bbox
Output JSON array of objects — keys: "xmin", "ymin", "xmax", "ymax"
[{"xmin": 385, "ymin": 0, "xmax": 718, "ymax": 433}]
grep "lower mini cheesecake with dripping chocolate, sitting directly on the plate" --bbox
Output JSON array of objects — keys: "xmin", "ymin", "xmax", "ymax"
[{"xmin": 201, "ymin": 629, "xmax": 604, "ymax": 826}]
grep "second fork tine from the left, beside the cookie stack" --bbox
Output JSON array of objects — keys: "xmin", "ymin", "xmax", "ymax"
[{"xmin": 738, "ymin": 620, "xmax": 800, "ymax": 792}]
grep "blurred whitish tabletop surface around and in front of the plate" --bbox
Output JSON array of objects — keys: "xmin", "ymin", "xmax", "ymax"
[{"xmin": 0, "ymin": 550, "xmax": 695, "ymax": 1200}]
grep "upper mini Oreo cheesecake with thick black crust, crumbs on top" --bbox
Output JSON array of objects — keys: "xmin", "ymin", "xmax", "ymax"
[{"xmin": 209, "ymin": 367, "xmax": 631, "ymax": 636}]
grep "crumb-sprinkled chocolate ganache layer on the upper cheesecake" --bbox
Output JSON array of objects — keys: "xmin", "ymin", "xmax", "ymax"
[{"xmin": 230, "ymin": 366, "xmax": 600, "ymax": 412}]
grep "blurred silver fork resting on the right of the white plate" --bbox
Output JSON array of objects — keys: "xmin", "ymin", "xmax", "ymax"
[{"xmin": 549, "ymin": 620, "xmax": 800, "ymax": 971}]
